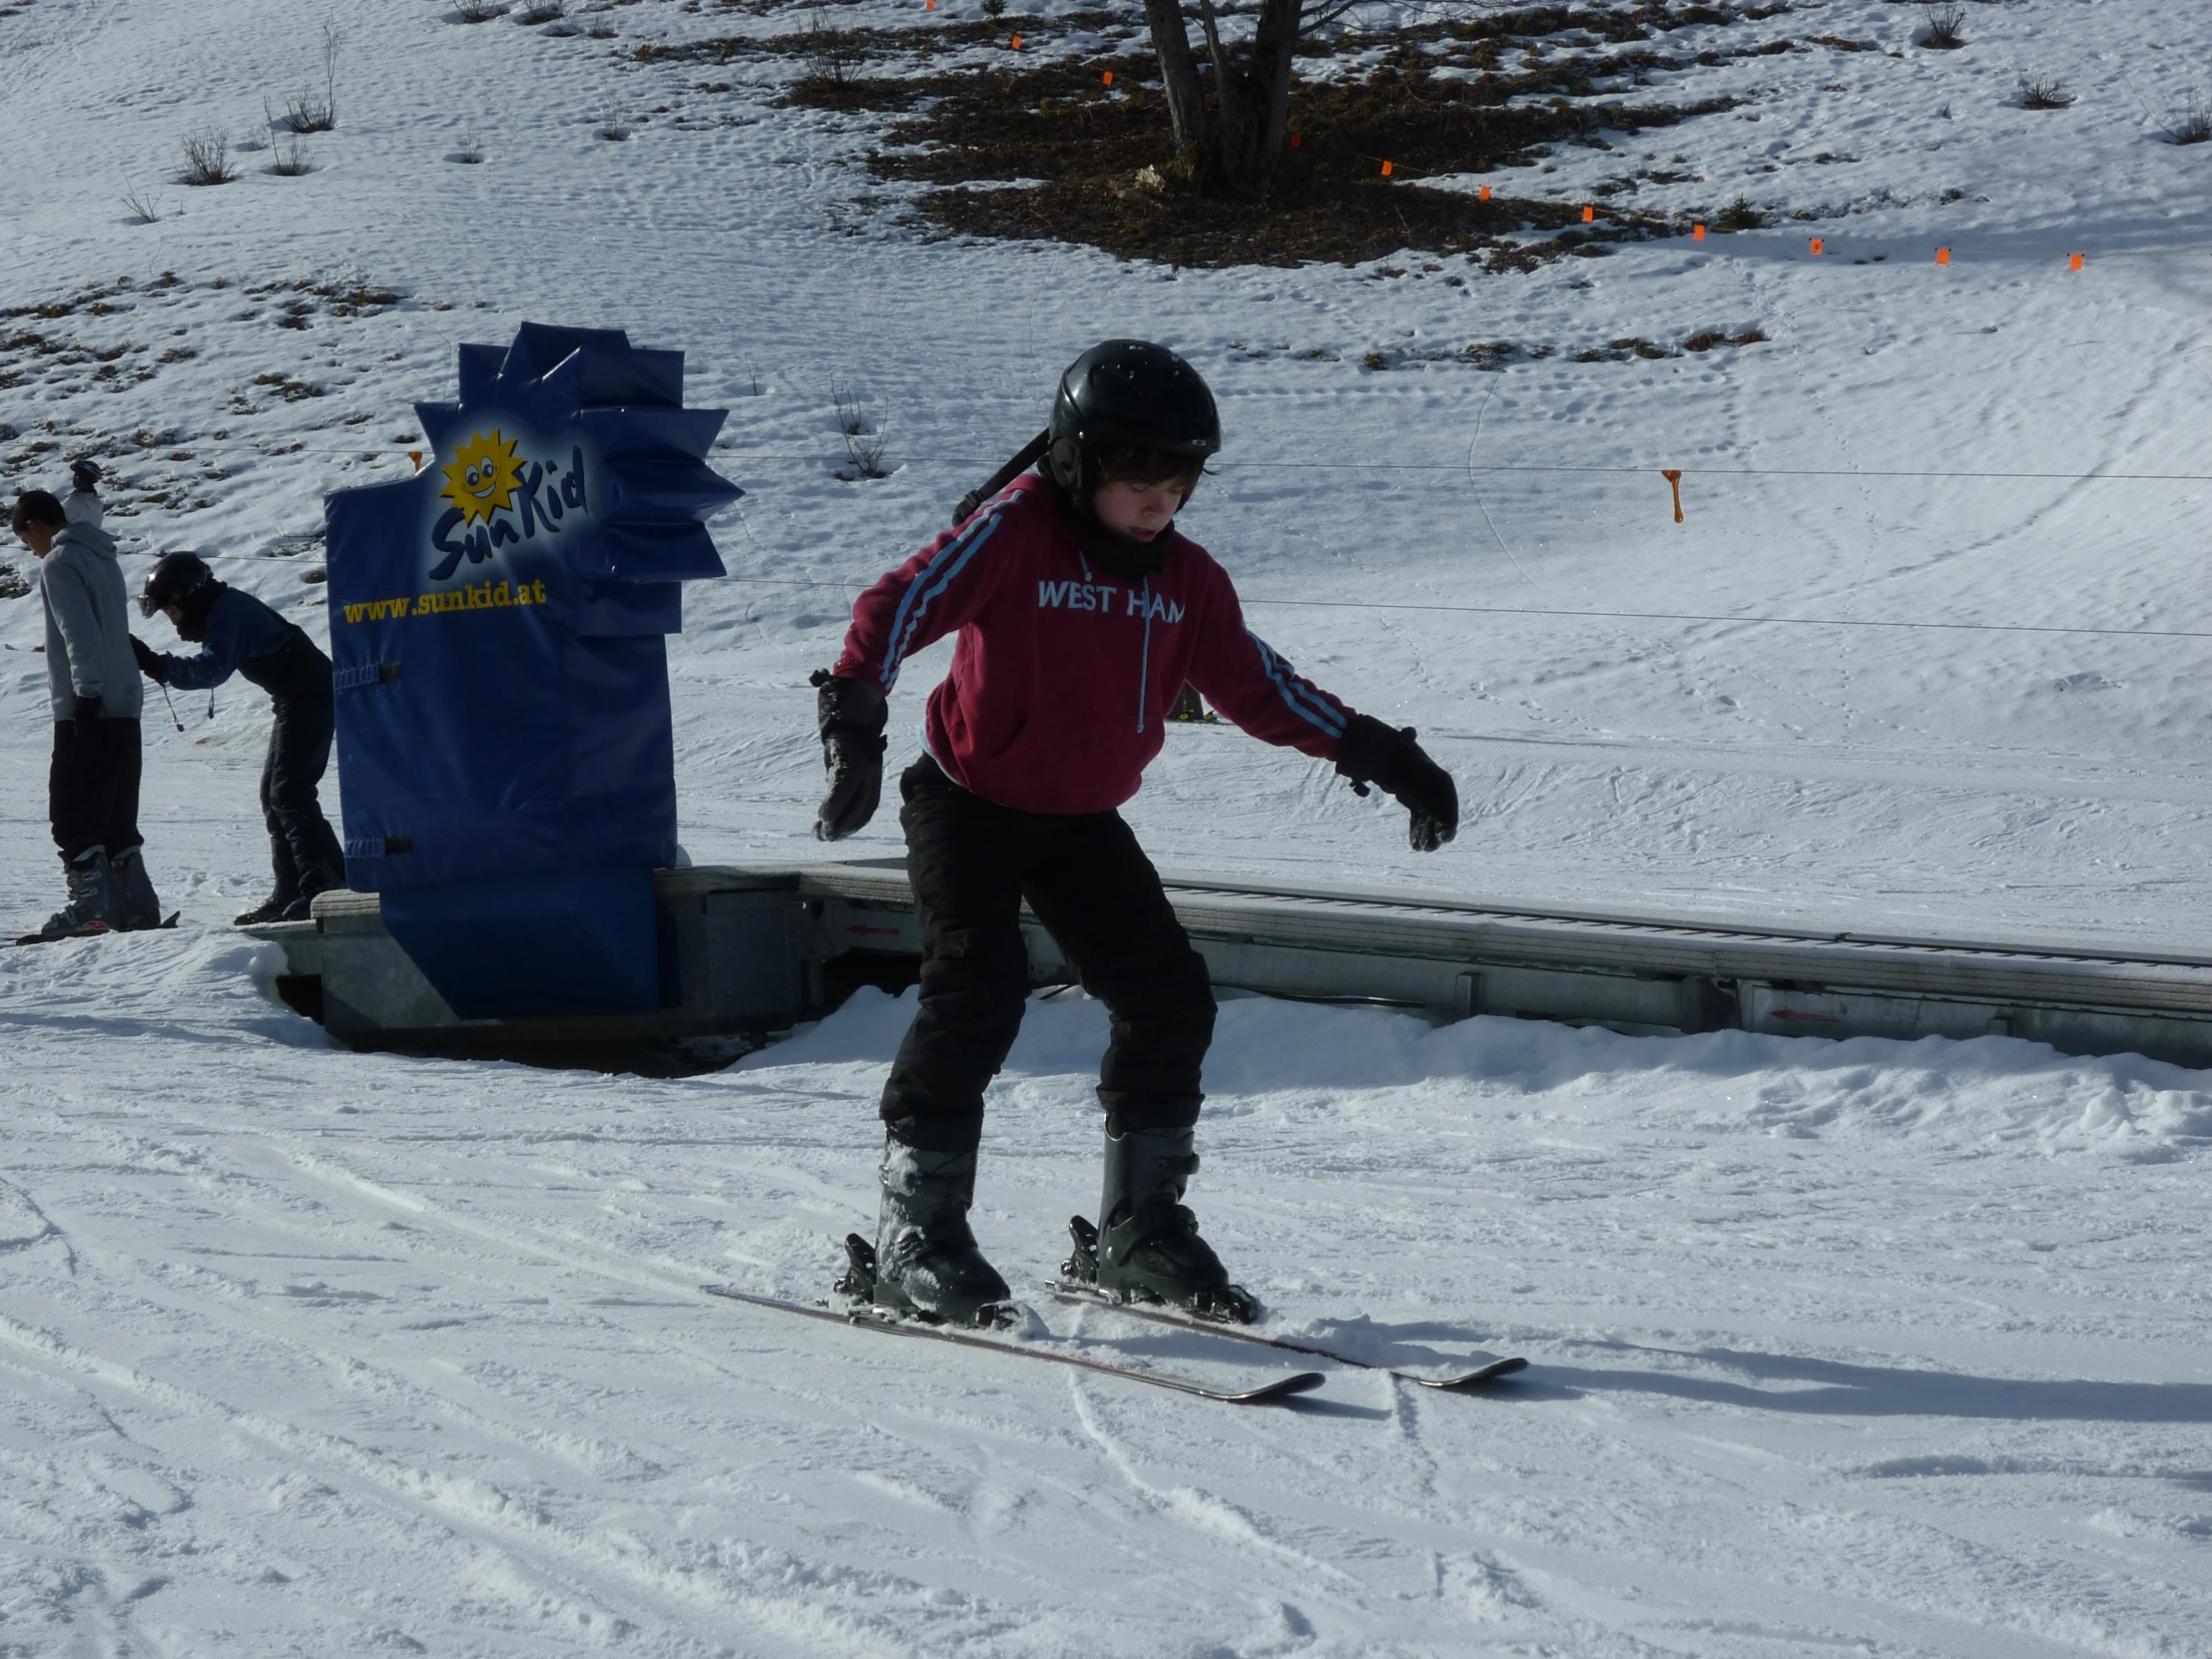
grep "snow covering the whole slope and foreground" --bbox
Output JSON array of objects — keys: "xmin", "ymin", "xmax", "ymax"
[{"xmin": 0, "ymin": 0, "xmax": 2212, "ymax": 1655}]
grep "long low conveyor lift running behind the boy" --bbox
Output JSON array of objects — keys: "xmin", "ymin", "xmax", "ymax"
[{"xmin": 250, "ymin": 858, "xmax": 2212, "ymax": 1071}]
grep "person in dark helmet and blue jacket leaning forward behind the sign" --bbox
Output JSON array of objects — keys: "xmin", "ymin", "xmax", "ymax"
[{"xmin": 131, "ymin": 553, "xmax": 345, "ymax": 927}]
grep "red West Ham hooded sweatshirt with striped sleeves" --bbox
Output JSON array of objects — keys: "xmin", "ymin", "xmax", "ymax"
[{"xmin": 833, "ymin": 473, "xmax": 1352, "ymax": 812}]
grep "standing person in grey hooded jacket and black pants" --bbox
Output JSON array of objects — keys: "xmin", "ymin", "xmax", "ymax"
[{"xmin": 9, "ymin": 489, "xmax": 162, "ymax": 942}]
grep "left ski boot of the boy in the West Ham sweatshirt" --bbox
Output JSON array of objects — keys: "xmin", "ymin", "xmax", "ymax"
[{"xmin": 836, "ymin": 1137, "xmax": 1015, "ymax": 1325}]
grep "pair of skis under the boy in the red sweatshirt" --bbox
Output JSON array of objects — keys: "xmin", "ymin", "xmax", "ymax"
[{"xmin": 704, "ymin": 1230, "xmax": 1528, "ymax": 1404}]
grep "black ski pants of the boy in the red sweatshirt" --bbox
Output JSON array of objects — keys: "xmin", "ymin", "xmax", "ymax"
[{"xmin": 882, "ymin": 757, "xmax": 1215, "ymax": 1153}]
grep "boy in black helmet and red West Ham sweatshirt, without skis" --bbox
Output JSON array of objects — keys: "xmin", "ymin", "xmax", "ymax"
[{"xmin": 814, "ymin": 340, "xmax": 1460, "ymax": 1323}]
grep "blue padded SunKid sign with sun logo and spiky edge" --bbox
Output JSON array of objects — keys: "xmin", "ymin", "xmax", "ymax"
[{"xmin": 325, "ymin": 323, "xmax": 744, "ymax": 1017}]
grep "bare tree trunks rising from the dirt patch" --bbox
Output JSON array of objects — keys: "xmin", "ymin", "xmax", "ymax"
[{"xmin": 1144, "ymin": 0, "xmax": 1356, "ymax": 199}]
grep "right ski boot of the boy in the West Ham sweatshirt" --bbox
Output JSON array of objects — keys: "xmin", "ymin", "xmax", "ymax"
[{"xmin": 1062, "ymin": 1128, "xmax": 1259, "ymax": 1325}]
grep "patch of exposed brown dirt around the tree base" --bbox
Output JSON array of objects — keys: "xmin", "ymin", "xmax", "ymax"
[{"xmin": 635, "ymin": 0, "xmax": 1794, "ymax": 270}]
